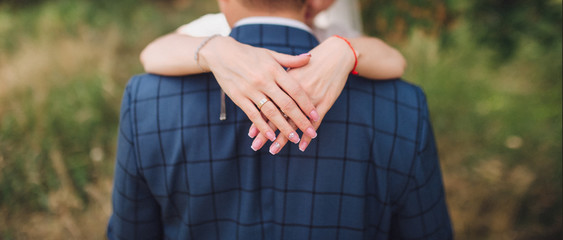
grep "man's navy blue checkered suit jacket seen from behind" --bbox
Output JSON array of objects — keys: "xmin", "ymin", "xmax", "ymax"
[{"xmin": 108, "ymin": 25, "xmax": 452, "ymax": 240}]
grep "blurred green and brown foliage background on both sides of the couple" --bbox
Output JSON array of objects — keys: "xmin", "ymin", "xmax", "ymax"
[{"xmin": 0, "ymin": 0, "xmax": 563, "ymax": 239}]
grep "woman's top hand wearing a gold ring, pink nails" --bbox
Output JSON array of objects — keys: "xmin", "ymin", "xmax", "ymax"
[{"xmin": 199, "ymin": 37, "xmax": 320, "ymax": 143}]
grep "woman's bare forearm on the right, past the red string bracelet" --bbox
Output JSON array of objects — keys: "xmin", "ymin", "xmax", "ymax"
[{"xmin": 349, "ymin": 37, "xmax": 407, "ymax": 79}]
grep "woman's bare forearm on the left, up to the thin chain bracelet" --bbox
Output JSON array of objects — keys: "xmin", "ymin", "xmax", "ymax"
[{"xmin": 140, "ymin": 33, "xmax": 214, "ymax": 76}]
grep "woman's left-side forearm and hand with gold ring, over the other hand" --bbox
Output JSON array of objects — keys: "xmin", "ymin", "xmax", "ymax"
[{"xmin": 141, "ymin": 33, "xmax": 319, "ymax": 143}]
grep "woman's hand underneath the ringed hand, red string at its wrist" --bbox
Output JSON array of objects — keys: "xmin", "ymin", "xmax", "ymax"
[{"xmin": 249, "ymin": 37, "xmax": 355, "ymax": 154}]
